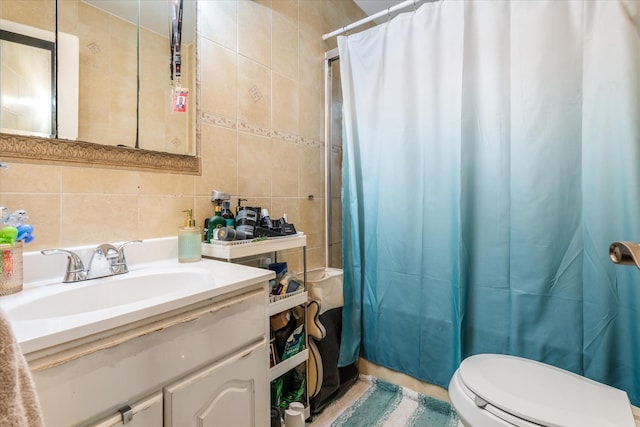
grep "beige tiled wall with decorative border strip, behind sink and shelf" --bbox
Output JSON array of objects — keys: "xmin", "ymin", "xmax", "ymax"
[{"xmin": 0, "ymin": 0, "xmax": 363, "ymax": 269}]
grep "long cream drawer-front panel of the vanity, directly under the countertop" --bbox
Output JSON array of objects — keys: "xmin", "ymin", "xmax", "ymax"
[{"xmin": 29, "ymin": 286, "xmax": 267, "ymax": 427}]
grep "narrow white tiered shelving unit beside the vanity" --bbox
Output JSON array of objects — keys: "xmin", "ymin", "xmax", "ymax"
[{"xmin": 202, "ymin": 237, "xmax": 311, "ymax": 418}]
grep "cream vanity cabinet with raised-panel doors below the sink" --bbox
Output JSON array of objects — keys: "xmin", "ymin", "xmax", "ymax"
[{"xmin": 26, "ymin": 281, "xmax": 269, "ymax": 427}]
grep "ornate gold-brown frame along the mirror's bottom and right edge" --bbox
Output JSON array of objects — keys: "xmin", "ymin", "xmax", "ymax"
[{"xmin": 0, "ymin": 0, "xmax": 202, "ymax": 175}]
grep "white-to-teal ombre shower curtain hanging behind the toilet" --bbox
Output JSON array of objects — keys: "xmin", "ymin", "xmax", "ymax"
[{"xmin": 338, "ymin": 0, "xmax": 640, "ymax": 405}]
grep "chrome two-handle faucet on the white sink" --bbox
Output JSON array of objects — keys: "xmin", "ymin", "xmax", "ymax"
[{"xmin": 41, "ymin": 240, "xmax": 142, "ymax": 283}]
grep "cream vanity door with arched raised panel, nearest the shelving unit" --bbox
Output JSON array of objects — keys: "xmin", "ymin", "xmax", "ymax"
[{"xmin": 164, "ymin": 341, "xmax": 269, "ymax": 427}]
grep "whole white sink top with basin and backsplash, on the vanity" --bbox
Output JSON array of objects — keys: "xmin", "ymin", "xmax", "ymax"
[{"xmin": 0, "ymin": 237, "xmax": 274, "ymax": 354}]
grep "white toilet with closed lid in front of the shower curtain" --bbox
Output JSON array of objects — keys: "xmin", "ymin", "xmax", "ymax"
[{"xmin": 449, "ymin": 354, "xmax": 635, "ymax": 427}]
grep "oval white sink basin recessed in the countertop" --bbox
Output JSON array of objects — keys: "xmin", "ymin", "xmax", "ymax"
[{"xmin": 7, "ymin": 268, "xmax": 209, "ymax": 320}]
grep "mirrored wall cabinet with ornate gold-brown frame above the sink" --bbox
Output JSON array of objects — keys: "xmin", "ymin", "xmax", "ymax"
[{"xmin": 0, "ymin": 0, "xmax": 200, "ymax": 174}]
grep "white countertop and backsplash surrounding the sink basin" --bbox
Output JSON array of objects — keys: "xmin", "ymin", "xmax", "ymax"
[{"xmin": 0, "ymin": 237, "xmax": 274, "ymax": 354}]
